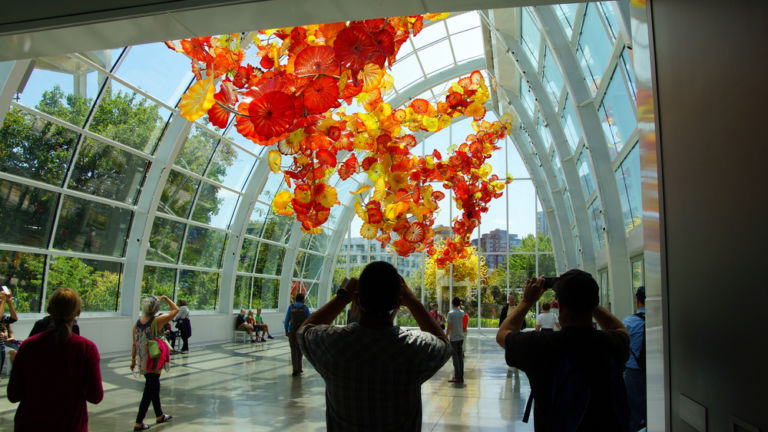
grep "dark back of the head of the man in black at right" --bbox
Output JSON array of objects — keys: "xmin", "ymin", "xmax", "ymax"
[{"xmin": 554, "ymin": 269, "xmax": 600, "ymax": 320}]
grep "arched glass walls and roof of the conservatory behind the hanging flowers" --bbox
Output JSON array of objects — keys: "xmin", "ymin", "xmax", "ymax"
[{"xmin": 0, "ymin": 2, "xmax": 641, "ymax": 320}]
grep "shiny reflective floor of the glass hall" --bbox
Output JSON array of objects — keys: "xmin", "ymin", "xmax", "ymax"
[{"xmin": 0, "ymin": 331, "xmax": 533, "ymax": 432}]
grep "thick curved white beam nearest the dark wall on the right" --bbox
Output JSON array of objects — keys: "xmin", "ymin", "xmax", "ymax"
[{"xmin": 533, "ymin": 6, "xmax": 634, "ymax": 316}]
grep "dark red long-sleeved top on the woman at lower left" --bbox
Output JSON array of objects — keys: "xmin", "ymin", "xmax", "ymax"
[{"xmin": 8, "ymin": 331, "xmax": 104, "ymax": 431}]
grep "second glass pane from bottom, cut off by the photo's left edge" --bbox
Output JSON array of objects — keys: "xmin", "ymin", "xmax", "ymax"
[{"xmin": 0, "ymin": 180, "xmax": 59, "ymax": 248}]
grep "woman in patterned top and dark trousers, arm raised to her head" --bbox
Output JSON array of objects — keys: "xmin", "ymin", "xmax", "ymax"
[{"xmin": 131, "ymin": 296, "xmax": 179, "ymax": 431}]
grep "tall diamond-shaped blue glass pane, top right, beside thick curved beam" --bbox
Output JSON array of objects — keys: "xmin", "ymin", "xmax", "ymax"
[{"xmin": 576, "ymin": 4, "xmax": 613, "ymax": 94}]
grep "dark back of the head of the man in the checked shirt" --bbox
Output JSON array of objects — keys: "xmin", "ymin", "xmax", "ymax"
[{"xmin": 357, "ymin": 261, "xmax": 401, "ymax": 314}]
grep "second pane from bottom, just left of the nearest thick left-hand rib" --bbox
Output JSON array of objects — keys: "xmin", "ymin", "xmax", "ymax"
[{"xmin": 53, "ymin": 196, "xmax": 132, "ymax": 257}]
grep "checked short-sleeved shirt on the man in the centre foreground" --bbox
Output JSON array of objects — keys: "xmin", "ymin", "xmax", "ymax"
[{"xmin": 298, "ymin": 323, "xmax": 451, "ymax": 432}]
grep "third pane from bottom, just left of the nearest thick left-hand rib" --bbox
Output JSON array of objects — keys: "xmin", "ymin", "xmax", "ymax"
[{"xmin": 67, "ymin": 139, "xmax": 149, "ymax": 204}]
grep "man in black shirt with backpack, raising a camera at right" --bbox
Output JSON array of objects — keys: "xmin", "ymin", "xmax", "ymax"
[{"xmin": 496, "ymin": 270, "xmax": 629, "ymax": 432}]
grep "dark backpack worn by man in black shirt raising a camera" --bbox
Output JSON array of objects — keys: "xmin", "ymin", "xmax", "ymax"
[{"xmin": 523, "ymin": 346, "xmax": 629, "ymax": 432}]
